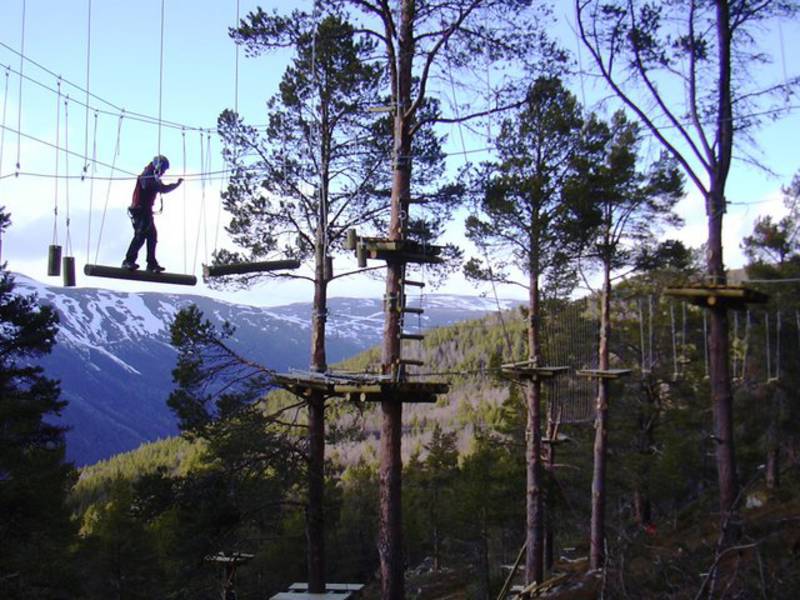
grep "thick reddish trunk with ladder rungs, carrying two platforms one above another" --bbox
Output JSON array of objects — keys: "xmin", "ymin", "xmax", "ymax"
[{"xmin": 378, "ymin": 0, "xmax": 414, "ymax": 600}]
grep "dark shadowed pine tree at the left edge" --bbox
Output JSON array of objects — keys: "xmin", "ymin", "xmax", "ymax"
[{"xmin": 0, "ymin": 207, "xmax": 74, "ymax": 598}]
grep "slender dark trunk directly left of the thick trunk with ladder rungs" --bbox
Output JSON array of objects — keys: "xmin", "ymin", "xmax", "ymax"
[{"xmin": 306, "ymin": 241, "xmax": 328, "ymax": 594}]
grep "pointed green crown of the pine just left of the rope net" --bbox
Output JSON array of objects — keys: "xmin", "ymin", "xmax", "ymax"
[{"xmin": 465, "ymin": 77, "xmax": 583, "ymax": 288}]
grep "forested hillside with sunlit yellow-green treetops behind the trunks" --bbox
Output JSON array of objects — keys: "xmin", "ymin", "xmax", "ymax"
[{"xmin": 73, "ymin": 276, "xmax": 800, "ymax": 598}]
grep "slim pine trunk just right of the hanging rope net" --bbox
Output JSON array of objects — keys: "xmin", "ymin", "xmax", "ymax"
[{"xmin": 589, "ymin": 262, "xmax": 611, "ymax": 569}]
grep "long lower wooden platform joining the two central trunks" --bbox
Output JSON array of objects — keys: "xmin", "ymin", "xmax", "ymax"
[{"xmin": 273, "ymin": 371, "xmax": 450, "ymax": 403}]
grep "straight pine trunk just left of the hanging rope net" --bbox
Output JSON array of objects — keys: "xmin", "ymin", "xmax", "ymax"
[{"xmin": 525, "ymin": 270, "xmax": 544, "ymax": 584}]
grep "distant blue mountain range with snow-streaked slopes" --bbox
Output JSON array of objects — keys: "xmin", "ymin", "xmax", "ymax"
[{"xmin": 16, "ymin": 275, "xmax": 513, "ymax": 465}]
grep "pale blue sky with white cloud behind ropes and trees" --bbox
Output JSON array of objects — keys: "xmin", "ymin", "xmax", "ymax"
[{"xmin": 0, "ymin": 0, "xmax": 800, "ymax": 305}]
